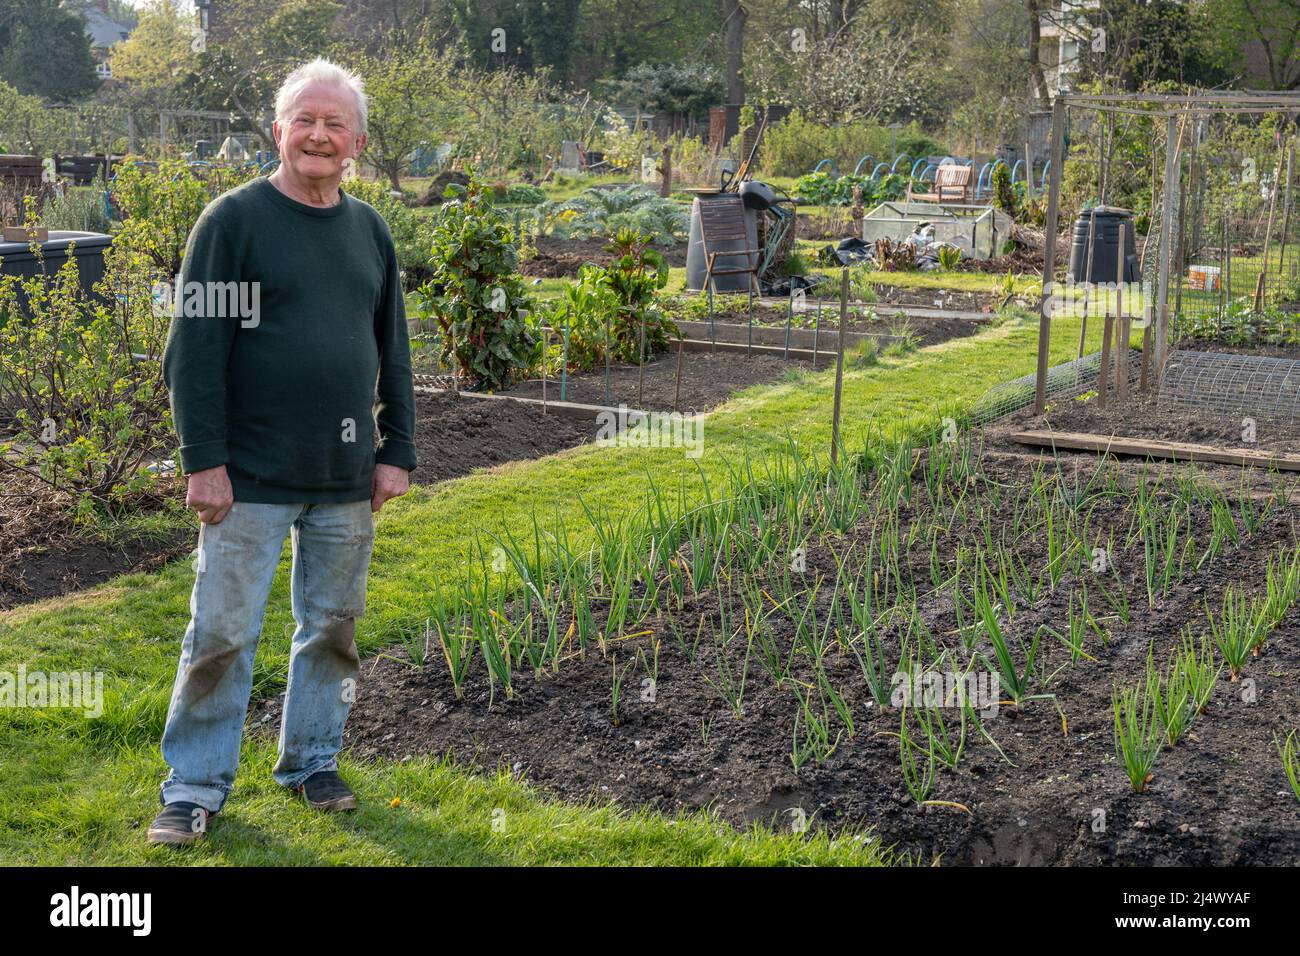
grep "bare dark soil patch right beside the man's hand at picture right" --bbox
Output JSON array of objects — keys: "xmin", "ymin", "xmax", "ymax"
[{"xmin": 411, "ymin": 392, "xmax": 595, "ymax": 484}]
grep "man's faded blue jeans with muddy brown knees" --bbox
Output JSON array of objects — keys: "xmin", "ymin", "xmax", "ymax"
[{"xmin": 160, "ymin": 501, "xmax": 374, "ymax": 813}]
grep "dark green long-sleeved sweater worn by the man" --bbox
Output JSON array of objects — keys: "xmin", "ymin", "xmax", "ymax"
[{"xmin": 163, "ymin": 178, "xmax": 416, "ymax": 503}]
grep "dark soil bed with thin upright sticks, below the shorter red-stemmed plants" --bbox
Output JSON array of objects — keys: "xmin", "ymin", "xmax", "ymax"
[{"xmin": 504, "ymin": 349, "xmax": 811, "ymax": 412}]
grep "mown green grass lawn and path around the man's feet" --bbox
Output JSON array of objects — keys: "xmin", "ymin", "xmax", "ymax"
[{"xmin": 0, "ymin": 303, "xmax": 1097, "ymax": 865}]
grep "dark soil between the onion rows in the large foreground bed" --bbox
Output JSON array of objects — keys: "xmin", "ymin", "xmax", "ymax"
[{"xmin": 252, "ymin": 434, "xmax": 1300, "ymax": 866}]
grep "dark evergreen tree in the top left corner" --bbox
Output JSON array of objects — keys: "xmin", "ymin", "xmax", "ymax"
[{"xmin": 0, "ymin": 0, "xmax": 99, "ymax": 103}]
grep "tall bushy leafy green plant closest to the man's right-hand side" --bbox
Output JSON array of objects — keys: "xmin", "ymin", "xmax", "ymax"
[{"xmin": 419, "ymin": 181, "xmax": 537, "ymax": 389}]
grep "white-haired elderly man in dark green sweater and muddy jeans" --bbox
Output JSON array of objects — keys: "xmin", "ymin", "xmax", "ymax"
[{"xmin": 148, "ymin": 60, "xmax": 416, "ymax": 844}]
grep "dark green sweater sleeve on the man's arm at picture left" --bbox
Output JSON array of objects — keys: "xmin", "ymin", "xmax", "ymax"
[{"xmin": 163, "ymin": 206, "xmax": 239, "ymax": 473}]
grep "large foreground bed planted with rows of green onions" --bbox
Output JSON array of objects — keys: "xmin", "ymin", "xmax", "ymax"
[{"xmin": 255, "ymin": 426, "xmax": 1300, "ymax": 865}]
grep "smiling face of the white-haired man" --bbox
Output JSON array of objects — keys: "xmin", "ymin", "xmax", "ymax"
[{"xmin": 274, "ymin": 83, "xmax": 367, "ymax": 187}]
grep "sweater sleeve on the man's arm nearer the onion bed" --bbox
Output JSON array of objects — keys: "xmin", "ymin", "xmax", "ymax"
[{"xmin": 374, "ymin": 225, "xmax": 416, "ymax": 471}]
